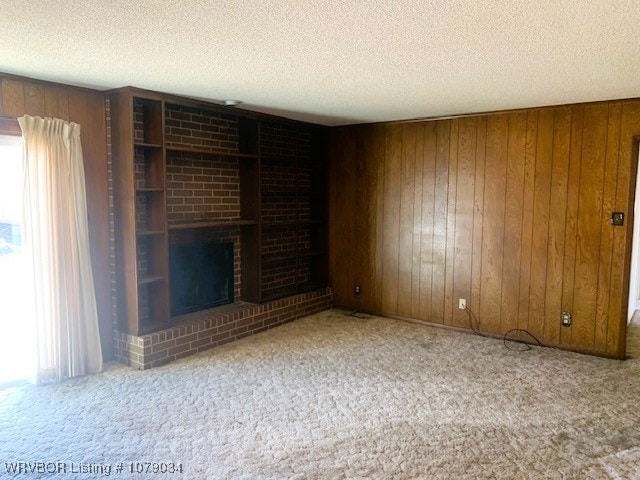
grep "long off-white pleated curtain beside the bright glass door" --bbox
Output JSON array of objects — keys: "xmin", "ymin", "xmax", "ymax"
[{"xmin": 18, "ymin": 116, "xmax": 102, "ymax": 383}]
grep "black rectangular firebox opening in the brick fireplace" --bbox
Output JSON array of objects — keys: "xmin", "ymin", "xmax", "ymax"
[{"xmin": 169, "ymin": 242, "xmax": 233, "ymax": 316}]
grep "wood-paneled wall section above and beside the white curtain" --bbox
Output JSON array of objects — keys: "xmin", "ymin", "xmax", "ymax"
[{"xmin": 0, "ymin": 74, "xmax": 113, "ymax": 359}]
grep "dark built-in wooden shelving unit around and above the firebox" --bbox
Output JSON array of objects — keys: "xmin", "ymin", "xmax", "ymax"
[{"xmin": 109, "ymin": 87, "xmax": 327, "ymax": 335}]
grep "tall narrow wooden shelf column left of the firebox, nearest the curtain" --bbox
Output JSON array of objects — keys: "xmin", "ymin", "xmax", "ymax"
[{"xmin": 108, "ymin": 89, "xmax": 169, "ymax": 335}]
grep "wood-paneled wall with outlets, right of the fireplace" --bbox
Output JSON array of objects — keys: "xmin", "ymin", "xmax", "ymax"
[{"xmin": 329, "ymin": 100, "xmax": 640, "ymax": 358}]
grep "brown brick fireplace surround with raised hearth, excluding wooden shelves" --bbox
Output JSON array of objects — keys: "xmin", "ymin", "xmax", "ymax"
[{"xmin": 107, "ymin": 97, "xmax": 333, "ymax": 369}]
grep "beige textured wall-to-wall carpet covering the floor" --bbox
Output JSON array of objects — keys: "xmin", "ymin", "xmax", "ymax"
[{"xmin": 0, "ymin": 310, "xmax": 640, "ymax": 479}]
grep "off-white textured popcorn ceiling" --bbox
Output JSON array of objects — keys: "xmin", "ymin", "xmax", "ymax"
[{"xmin": 0, "ymin": 0, "xmax": 640, "ymax": 125}]
